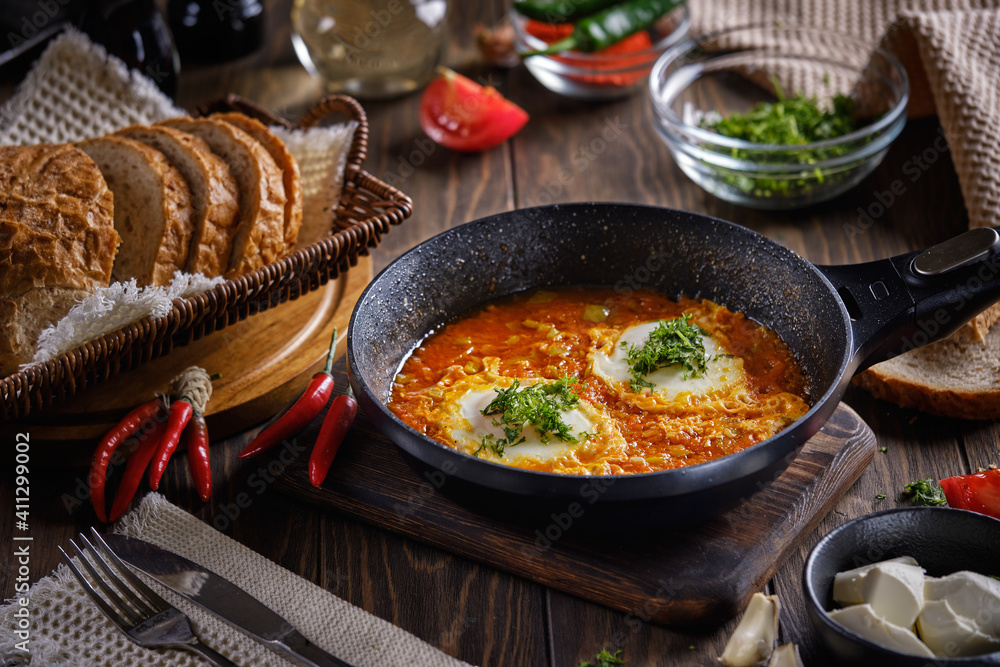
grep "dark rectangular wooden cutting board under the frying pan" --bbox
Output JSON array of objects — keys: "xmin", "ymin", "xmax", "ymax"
[{"xmin": 276, "ymin": 360, "xmax": 876, "ymax": 625}]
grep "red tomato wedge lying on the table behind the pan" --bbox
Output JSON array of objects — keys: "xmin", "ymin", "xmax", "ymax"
[{"xmin": 420, "ymin": 68, "xmax": 528, "ymax": 152}]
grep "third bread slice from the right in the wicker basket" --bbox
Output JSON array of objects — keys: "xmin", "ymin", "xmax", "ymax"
[{"xmin": 115, "ymin": 125, "xmax": 239, "ymax": 278}]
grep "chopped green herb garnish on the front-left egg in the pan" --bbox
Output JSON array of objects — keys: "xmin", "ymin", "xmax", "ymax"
[{"xmin": 475, "ymin": 376, "xmax": 580, "ymax": 456}]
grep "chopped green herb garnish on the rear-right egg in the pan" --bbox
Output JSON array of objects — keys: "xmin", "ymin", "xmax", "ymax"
[{"xmin": 622, "ymin": 313, "xmax": 708, "ymax": 392}]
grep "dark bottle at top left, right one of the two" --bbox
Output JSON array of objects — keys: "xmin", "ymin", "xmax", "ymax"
[{"xmin": 167, "ymin": 0, "xmax": 264, "ymax": 64}]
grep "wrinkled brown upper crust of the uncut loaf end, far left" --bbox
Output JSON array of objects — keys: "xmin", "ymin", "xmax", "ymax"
[{"xmin": 0, "ymin": 144, "xmax": 121, "ymax": 297}]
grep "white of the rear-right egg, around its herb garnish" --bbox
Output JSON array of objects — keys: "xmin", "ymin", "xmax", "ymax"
[{"xmin": 590, "ymin": 320, "xmax": 745, "ymax": 401}]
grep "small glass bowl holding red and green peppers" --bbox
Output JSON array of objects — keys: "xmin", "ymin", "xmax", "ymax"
[{"xmin": 510, "ymin": 3, "xmax": 691, "ymax": 100}]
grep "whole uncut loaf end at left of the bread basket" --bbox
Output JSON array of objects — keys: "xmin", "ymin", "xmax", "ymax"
[{"xmin": 0, "ymin": 144, "xmax": 121, "ymax": 375}]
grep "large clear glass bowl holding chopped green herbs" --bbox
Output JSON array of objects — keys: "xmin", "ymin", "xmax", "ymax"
[{"xmin": 649, "ymin": 25, "xmax": 909, "ymax": 209}]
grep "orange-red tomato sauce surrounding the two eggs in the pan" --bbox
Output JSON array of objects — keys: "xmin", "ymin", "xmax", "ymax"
[{"xmin": 389, "ymin": 287, "xmax": 808, "ymax": 474}]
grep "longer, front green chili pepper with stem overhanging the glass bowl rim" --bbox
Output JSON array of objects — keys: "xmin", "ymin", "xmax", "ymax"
[{"xmin": 521, "ymin": 0, "xmax": 684, "ymax": 58}]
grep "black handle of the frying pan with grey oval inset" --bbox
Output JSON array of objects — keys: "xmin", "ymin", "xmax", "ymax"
[{"xmin": 817, "ymin": 227, "xmax": 1000, "ymax": 371}]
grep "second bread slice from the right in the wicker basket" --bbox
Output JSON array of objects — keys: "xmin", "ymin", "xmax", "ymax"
[{"xmin": 159, "ymin": 118, "xmax": 286, "ymax": 275}]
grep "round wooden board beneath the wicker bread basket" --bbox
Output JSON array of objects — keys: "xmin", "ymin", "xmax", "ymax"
[{"xmin": 10, "ymin": 256, "xmax": 372, "ymax": 458}]
